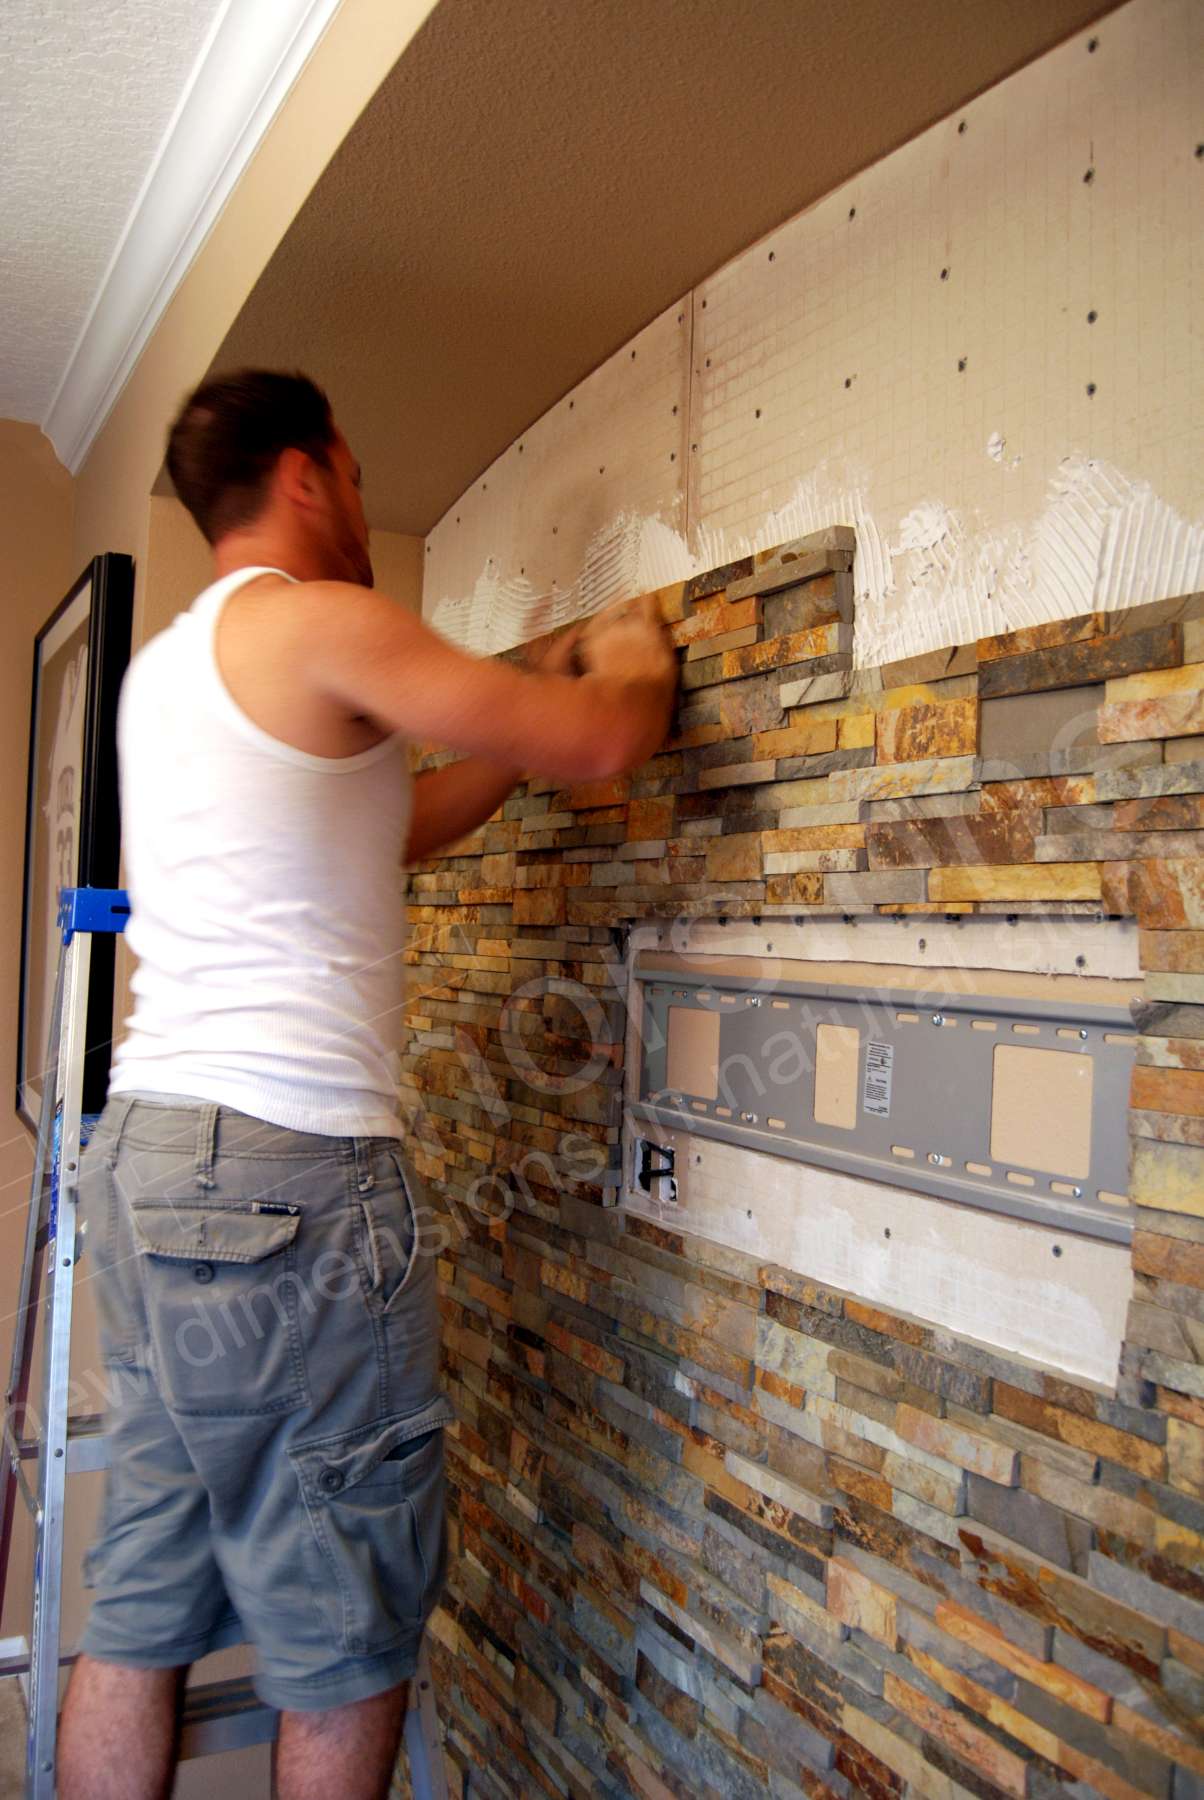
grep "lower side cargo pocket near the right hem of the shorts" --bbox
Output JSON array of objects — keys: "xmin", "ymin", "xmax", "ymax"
[{"xmin": 290, "ymin": 1400, "xmax": 455, "ymax": 1656}]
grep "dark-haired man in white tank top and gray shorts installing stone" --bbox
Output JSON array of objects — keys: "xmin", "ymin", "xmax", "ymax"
[{"xmin": 59, "ymin": 371, "xmax": 675, "ymax": 1800}]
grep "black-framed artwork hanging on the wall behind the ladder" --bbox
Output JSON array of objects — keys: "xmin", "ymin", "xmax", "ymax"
[{"xmin": 16, "ymin": 556, "xmax": 133, "ymax": 1130}]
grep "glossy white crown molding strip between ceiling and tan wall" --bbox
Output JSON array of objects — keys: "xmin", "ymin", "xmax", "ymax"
[{"xmin": 43, "ymin": 0, "xmax": 340, "ymax": 475}]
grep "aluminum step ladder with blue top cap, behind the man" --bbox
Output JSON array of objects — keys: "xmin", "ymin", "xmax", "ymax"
[{"xmin": 0, "ymin": 887, "xmax": 448, "ymax": 1800}]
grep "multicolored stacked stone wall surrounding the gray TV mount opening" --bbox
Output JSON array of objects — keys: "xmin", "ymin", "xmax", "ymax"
[{"xmin": 405, "ymin": 529, "xmax": 1204, "ymax": 1800}]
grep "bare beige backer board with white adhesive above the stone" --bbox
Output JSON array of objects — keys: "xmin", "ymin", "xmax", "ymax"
[{"xmin": 425, "ymin": 0, "xmax": 1204, "ymax": 669}]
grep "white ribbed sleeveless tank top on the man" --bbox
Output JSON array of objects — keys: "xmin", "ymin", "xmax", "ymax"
[{"xmin": 110, "ymin": 567, "xmax": 412, "ymax": 1138}]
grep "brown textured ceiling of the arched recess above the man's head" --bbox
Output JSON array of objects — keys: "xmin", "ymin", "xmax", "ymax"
[{"xmin": 214, "ymin": 0, "xmax": 1109, "ymax": 533}]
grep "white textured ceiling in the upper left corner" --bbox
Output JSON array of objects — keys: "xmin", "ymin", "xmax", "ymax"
[{"xmin": 0, "ymin": 0, "xmax": 220, "ymax": 421}]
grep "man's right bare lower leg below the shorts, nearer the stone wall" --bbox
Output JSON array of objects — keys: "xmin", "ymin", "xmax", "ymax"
[{"xmin": 272, "ymin": 1681, "xmax": 410, "ymax": 1800}]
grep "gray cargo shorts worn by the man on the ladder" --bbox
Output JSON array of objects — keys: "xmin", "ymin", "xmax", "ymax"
[{"xmin": 79, "ymin": 1094, "xmax": 455, "ymax": 1710}]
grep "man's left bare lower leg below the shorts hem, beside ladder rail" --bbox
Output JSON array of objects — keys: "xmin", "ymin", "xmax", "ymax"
[{"xmin": 58, "ymin": 1656, "xmax": 184, "ymax": 1800}]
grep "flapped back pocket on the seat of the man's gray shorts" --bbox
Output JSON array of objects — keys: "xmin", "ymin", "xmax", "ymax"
[{"xmin": 131, "ymin": 1201, "xmax": 308, "ymax": 1417}]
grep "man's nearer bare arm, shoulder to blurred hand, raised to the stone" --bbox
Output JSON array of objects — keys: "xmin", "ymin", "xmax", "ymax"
[{"xmin": 292, "ymin": 581, "xmax": 675, "ymax": 781}]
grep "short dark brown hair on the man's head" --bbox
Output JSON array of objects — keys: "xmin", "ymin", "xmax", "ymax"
[{"xmin": 167, "ymin": 369, "xmax": 335, "ymax": 544}]
